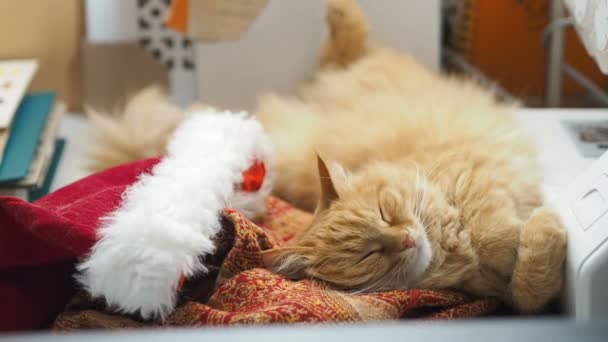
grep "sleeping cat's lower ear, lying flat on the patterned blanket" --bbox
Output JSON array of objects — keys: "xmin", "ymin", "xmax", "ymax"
[{"xmin": 261, "ymin": 246, "xmax": 310, "ymax": 279}]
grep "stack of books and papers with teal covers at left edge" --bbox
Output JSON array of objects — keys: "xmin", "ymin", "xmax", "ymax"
[{"xmin": 0, "ymin": 60, "xmax": 66, "ymax": 201}]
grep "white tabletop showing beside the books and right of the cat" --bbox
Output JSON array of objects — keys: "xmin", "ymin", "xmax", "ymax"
[{"xmin": 51, "ymin": 109, "xmax": 608, "ymax": 198}]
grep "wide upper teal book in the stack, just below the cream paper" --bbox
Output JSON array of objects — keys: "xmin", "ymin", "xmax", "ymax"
[{"xmin": 0, "ymin": 92, "xmax": 55, "ymax": 182}]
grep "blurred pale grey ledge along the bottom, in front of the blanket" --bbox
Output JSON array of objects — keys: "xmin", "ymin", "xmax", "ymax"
[{"xmin": 7, "ymin": 317, "xmax": 608, "ymax": 342}]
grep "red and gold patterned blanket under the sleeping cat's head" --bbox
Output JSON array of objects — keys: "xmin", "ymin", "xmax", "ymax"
[{"xmin": 53, "ymin": 197, "xmax": 502, "ymax": 331}]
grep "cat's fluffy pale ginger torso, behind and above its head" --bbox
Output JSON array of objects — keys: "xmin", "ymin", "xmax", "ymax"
[{"xmin": 257, "ymin": 49, "xmax": 541, "ymax": 216}]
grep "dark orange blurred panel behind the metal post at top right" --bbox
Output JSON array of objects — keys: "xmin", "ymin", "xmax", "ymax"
[{"xmin": 451, "ymin": 0, "xmax": 608, "ymax": 97}]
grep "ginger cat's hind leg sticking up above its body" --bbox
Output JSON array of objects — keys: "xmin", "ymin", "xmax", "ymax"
[{"xmin": 320, "ymin": 0, "xmax": 371, "ymax": 68}]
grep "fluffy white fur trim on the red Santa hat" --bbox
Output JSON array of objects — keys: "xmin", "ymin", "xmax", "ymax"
[{"xmin": 78, "ymin": 110, "xmax": 272, "ymax": 319}]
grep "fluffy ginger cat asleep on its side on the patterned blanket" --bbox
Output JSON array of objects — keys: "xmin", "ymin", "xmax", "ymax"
[{"xmin": 257, "ymin": 0, "xmax": 566, "ymax": 312}]
